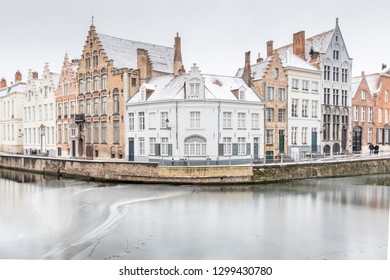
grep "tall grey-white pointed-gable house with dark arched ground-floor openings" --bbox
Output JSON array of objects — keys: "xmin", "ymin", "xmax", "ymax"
[{"xmin": 278, "ymin": 19, "xmax": 352, "ymax": 154}]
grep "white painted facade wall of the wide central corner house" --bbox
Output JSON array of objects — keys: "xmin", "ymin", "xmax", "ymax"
[{"xmin": 126, "ymin": 100, "xmax": 264, "ymax": 161}]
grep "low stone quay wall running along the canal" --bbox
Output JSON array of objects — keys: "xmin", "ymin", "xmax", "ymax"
[{"xmin": 0, "ymin": 154, "xmax": 390, "ymax": 185}]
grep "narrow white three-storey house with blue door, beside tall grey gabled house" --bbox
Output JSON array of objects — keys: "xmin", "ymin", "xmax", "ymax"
[{"xmin": 279, "ymin": 50, "xmax": 321, "ymax": 160}]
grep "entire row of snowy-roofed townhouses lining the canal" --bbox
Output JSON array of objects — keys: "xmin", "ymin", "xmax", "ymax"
[{"xmin": 0, "ymin": 19, "xmax": 390, "ymax": 165}]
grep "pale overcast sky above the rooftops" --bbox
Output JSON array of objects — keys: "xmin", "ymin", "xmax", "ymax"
[{"xmin": 0, "ymin": 0, "xmax": 390, "ymax": 82}]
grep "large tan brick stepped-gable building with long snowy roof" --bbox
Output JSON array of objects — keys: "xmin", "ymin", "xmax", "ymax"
[{"xmin": 75, "ymin": 25, "xmax": 174, "ymax": 159}]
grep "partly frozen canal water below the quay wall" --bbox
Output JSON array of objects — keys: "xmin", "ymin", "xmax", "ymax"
[{"xmin": 0, "ymin": 167, "xmax": 390, "ymax": 260}]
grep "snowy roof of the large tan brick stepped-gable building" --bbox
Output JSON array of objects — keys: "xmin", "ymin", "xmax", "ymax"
[{"xmin": 97, "ymin": 33, "xmax": 174, "ymax": 73}]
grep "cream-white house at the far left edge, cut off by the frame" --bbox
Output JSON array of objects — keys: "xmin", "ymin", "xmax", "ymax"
[{"xmin": 0, "ymin": 71, "xmax": 26, "ymax": 154}]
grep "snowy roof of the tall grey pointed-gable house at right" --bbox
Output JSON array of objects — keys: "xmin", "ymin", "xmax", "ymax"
[{"xmin": 276, "ymin": 29, "xmax": 334, "ymax": 59}]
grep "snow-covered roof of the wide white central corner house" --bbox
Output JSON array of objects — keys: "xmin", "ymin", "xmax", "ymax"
[{"xmin": 127, "ymin": 74, "xmax": 262, "ymax": 105}]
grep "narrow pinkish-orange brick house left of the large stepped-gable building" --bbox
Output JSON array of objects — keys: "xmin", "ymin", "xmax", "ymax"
[{"xmin": 56, "ymin": 54, "xmax": 79, "ymax": 158}]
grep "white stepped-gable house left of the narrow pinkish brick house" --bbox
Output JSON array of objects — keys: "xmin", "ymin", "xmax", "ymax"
[{"xmin": 23, "ymin": 63, "xmax": 59, "ymax": 156}]
